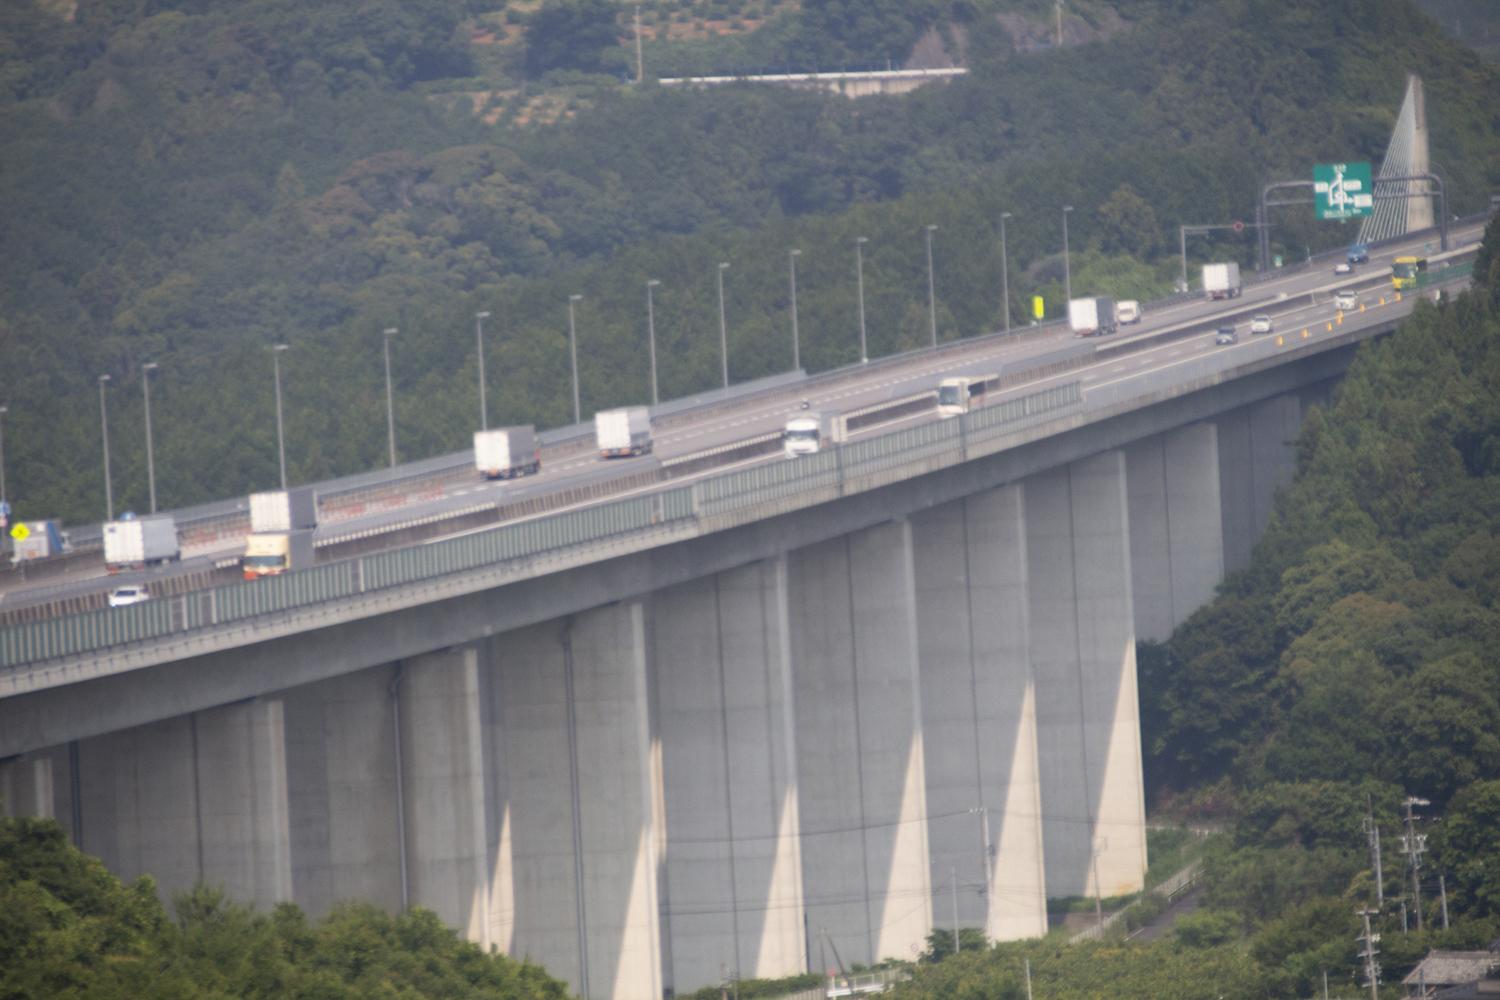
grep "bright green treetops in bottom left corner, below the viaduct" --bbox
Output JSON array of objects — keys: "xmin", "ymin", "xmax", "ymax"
[{"xmin": 0, "ymin": 820, "xmax": 569, "ymax": 1000}]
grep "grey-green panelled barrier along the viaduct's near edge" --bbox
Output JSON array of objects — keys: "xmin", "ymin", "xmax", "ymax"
[{"xmin": 0, "ymin": 382, "xmax": 1083, "ymax": 667}]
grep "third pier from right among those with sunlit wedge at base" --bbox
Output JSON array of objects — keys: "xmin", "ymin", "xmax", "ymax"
[{"xmin": 788, "ymin": 520, "xmax": 932, "ymax": 963}]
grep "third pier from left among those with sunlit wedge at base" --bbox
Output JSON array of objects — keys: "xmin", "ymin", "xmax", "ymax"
[{"xmin": 651, "ymin": 559, "xmax": 807, "ymax": 993}]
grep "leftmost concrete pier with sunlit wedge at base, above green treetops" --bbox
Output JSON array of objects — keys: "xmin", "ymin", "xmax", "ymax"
[{"xmin": 401, "ymin": 648, "xmax": 491, "ymax": 946}]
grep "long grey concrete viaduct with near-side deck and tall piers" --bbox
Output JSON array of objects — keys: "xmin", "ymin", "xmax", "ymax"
[{"xmin": 0, "ymin": 229, "xmax": 1476, "ymax": 1000}]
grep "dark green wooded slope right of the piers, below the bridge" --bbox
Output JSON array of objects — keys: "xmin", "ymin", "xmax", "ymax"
[{"xmin": 876, "ymin": 219, "xmax": 1500, "ymax": 1000}]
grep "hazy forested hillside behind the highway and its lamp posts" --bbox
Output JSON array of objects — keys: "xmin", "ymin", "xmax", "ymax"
[{"xmin": 0, "ymin": 0, "xmax": 1500, "ymax": 522}]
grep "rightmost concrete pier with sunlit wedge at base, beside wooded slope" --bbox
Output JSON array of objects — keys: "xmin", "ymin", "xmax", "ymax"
[{"xmin": 1026, "ymin": 451, "xmax": 1146, "ymax": 897}]
